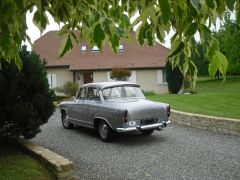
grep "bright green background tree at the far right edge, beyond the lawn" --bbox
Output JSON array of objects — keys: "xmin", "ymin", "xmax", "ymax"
[{"xmin": 214, "ymin": 12, "xmax": 240, "ymax": 74}]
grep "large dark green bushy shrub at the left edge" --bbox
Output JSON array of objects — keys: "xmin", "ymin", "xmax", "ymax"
[{"xmin": 0, "ymin": 47, "xmax": 54, "ymax": 138}]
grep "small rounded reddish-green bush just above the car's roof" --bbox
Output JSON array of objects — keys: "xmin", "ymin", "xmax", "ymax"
[{"xmin": 111, "ymin": 67, "xmax": 131, "ymax": 81}]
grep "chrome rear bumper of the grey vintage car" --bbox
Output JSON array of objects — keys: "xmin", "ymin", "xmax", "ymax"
[{"xmin": 116, "ymin": 120, "xmax": 171, "ymax": 132}]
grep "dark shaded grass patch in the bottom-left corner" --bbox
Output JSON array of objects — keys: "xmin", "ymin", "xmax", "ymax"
[{"xmin": 0, "ymin": 144, "xmax": 54, "ymax": 180}]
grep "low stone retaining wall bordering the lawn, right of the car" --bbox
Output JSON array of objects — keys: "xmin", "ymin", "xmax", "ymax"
[{"xmin": 170, "ymin": 110, "xmax": 240, "ymax": 136}]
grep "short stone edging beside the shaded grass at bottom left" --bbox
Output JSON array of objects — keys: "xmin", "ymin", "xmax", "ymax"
[{"xmin": 19, "ymin": 139, "xmax": 76, "ymax": 180}]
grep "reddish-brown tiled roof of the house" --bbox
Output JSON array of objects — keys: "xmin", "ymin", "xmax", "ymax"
[{"xmin": 33, "ymin": 31, "xmax": 169, "ymax": 70}]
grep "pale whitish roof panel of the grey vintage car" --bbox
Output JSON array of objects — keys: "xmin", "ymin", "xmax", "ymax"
[{"xmin": 83, "ymin": 81, "xmax": 139, "ymax": 89}]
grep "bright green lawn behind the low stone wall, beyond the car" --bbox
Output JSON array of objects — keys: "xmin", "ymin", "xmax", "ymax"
[{"xmin": 147, "ymin": 76, "xmax": 240, "ymax": 119}]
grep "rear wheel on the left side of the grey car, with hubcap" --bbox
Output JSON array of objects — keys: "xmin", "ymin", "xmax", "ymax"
[{"xmin": 98, "ymin": 121, "xmax": 113, "ymax": 142}]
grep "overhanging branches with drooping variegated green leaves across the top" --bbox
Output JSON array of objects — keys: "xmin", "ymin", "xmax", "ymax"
[{"xmin": 0, "ymin": 0, "xmax": 240, "ymax": 84}]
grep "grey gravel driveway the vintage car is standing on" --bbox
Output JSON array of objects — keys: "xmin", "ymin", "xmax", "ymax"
[{"xmin": 32, "ymin": 111, "xmax": 240, "ymax": 180}]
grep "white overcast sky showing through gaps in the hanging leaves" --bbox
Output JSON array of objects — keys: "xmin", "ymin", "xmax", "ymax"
[{"xmin": 25, "ymin": 11, "xmax": 223, "ymax": 50}]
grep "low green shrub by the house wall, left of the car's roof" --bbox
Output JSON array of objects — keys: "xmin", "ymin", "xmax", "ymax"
[{"xmin": 54, "ymin": 81, "xmax": 79, "ymax": 97}]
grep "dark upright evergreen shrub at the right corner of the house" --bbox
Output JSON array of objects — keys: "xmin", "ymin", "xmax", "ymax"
[{"xmin": 166, "ymin": 61, "xmax": 183, "ymax": 94}]
